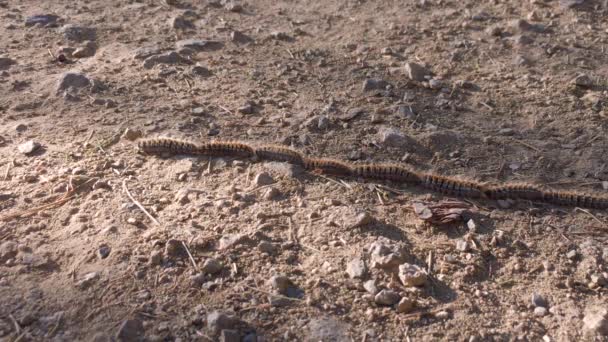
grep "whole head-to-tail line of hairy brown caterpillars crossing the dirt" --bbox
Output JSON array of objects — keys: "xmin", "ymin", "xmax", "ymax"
[{"xmin": 139, "ymin": 138, "xmax": 608, "ymax": 209}]
